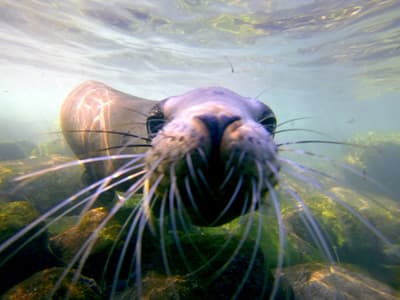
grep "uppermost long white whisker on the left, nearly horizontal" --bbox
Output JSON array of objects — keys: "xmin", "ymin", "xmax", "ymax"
[{"xmin": 14, "ymin": 154, "xmax": 144, "ymax": 181}]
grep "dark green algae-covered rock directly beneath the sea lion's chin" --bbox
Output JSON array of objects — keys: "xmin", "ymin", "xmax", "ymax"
[{"xmin": 131, "ymin": 212, "xmax": 290, "ymax": 299}]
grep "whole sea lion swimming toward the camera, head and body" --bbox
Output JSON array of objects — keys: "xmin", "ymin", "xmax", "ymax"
[{"xmin": 60, "ymin": 81, "xmax": 279, "ymax": 226}]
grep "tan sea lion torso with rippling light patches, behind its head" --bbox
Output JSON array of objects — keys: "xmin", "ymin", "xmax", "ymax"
[{"xmin": 60, "ymin": 81, "xmax": 156, "ymax": 180}]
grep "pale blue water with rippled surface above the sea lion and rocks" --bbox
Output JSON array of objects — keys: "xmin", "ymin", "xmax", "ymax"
[{"xmin": 0, "ymin": 0, "xmax": 400, "ymax": 298}]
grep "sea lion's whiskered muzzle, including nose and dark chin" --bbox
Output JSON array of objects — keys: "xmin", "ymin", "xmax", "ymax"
[{"xmin": 146, "ymin": 116, "xmax": 279, "ymax": 226}]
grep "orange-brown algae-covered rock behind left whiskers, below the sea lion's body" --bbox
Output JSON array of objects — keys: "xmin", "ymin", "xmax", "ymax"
[{"xmin": 50, "ymin": 200, "xmax": 151, "ymax": 284}]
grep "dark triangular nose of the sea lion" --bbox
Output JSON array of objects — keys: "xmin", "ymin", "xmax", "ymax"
[{"xmin": 197, "ymin": 115, "xmax": 240, "ymax": 146}]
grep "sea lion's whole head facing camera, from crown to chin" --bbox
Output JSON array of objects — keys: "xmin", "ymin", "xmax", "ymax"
[{"xmin": 145, "ymin": 88, "xmax": 279, "ymax": 226}]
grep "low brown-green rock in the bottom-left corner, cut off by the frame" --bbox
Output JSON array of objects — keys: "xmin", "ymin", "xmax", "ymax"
[{"xmin": 2, "ymin": 268, "xmax": 103, "ymax": 300}]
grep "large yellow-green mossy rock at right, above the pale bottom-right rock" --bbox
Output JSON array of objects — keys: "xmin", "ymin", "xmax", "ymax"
[{"xmin": 285, "ymin": 187, "xmax": 400, "ymax": 288}]
